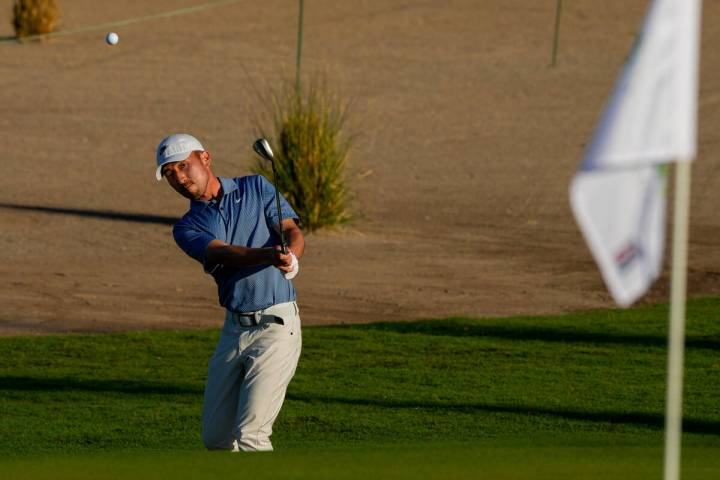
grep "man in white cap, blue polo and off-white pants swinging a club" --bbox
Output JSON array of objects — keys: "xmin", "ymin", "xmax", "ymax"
[{"xmin": 156, "ymin": 134, "xmax": 305, "ymax": 451}]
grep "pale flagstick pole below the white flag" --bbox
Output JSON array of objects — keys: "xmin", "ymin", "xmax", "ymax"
[{"xmin": 664, "ymin": 161, "xmax": 690, "ymax": 480}]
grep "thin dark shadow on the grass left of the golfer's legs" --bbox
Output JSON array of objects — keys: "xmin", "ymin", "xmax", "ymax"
[{"xmin": 0, "ymin": 376, "xmax": 203, "ymax": 395}]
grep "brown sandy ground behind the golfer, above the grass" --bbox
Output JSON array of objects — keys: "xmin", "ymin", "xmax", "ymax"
[{"xmin": 0, "ymin": 0, "xmax": 720, "ymax": 335}]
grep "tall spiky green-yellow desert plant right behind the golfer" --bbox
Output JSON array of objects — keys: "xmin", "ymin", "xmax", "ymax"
[{"xmin": 252, "ymin": 76, "xmax": 351, "ymax": 231}]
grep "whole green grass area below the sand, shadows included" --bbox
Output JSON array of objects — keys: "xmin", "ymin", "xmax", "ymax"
[{"xmin": 0, "ymin": 298, "xmax": 720, "ymax": 478}]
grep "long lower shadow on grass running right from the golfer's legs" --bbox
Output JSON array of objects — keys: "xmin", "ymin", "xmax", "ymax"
[{"xmin": 286, "ymin": 393, "xmax": 720, "ymax": 435}]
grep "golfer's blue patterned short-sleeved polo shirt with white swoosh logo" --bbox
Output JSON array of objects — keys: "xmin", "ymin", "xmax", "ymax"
[{"xmin": 173, "ymin": 175, "xmax": 298, "ymax": 313}]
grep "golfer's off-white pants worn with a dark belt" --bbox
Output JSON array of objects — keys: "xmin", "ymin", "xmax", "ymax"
[{"xmin": 202, "ymin": 302, "xmax": 302, "ymax": 451}]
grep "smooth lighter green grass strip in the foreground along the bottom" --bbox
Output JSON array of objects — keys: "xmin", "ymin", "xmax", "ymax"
[{"xmin": 1, "ymin": 442, "xmax": 720, "ymax": 480}]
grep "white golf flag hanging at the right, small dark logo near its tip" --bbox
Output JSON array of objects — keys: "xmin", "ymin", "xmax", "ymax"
[{"xmin": 570, "ymin": 0, "xmax": 700, "ymax": 306}]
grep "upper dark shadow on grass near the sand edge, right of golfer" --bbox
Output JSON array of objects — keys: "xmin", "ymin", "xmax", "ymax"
[{"xmin": 354, "ymin": 318, "xmax": 720, "ymax": 350}]
